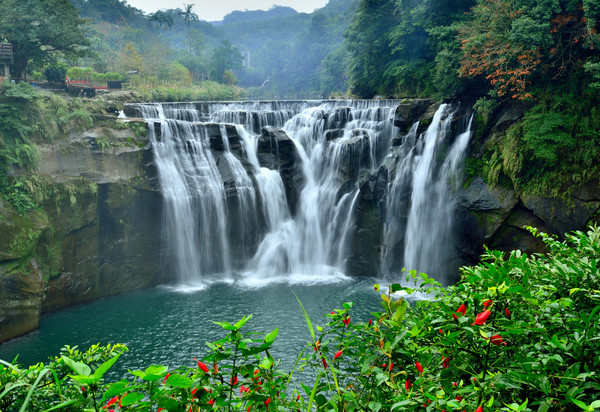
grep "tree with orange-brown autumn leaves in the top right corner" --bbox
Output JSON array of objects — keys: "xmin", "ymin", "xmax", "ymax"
[{"xmin": 459, "ymin": 0, "xmax": 600, "ymax": 100}]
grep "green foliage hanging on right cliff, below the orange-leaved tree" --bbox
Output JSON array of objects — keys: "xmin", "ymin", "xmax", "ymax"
[{"xmin": 478, "ymin": 89, "xmax": 600, "ymax": 197}]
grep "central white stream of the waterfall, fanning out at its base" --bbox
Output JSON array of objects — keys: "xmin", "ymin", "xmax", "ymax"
[{"xmin": 250, "ymin": 103, "xmax": 400, "ymax": 278}]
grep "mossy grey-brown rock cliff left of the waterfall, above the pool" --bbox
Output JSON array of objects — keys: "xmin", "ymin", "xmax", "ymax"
[{"xmin": 0, "ymin": 129, "xmax": 164, "ymax": 342}]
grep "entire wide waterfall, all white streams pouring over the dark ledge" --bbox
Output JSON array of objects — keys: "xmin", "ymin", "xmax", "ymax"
[{"xmin": 130, "ymin": 101, "xmax": 468, "ymax": 284}]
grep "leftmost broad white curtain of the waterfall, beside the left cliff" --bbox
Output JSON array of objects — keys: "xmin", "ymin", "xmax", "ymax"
[{"xmin": 142, "ymin": 106, "xmax": 230, "ymax": 282}]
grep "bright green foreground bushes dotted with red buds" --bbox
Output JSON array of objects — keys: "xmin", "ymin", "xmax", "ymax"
[{"xmin": 0, "ymin": 227, "xmax": 600, "ymax": 412}]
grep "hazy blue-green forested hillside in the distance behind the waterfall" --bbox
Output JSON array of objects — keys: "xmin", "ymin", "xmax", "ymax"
[{"xmin": 63, "ymin": 0, "xmax": 359, "ymax": 98}]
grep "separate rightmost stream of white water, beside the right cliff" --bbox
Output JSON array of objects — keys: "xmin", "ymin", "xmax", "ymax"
[{"xmin": 382, "ymin": 104, "xmax": 472, "ymax": 283}]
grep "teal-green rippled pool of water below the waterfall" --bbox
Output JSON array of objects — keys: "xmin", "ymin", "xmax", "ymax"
[{"xmin": 0, "ymin": 277, "xmax": 381, "ymax": 376}]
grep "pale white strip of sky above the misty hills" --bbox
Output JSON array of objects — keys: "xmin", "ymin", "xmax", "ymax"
[{"xmin": 127, "ymin": 0, "xmax": 327, "ymax": 21}]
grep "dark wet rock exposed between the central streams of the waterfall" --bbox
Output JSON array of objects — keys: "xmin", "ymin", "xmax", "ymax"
[{"xmin": 257, "ymin": 126, "xmax": 304, "ymax": 215}]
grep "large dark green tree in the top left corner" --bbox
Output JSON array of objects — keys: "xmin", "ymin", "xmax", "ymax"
[{"xmin": 0, "ymin": 0, "xmax": 89, "ymax": 77}]
